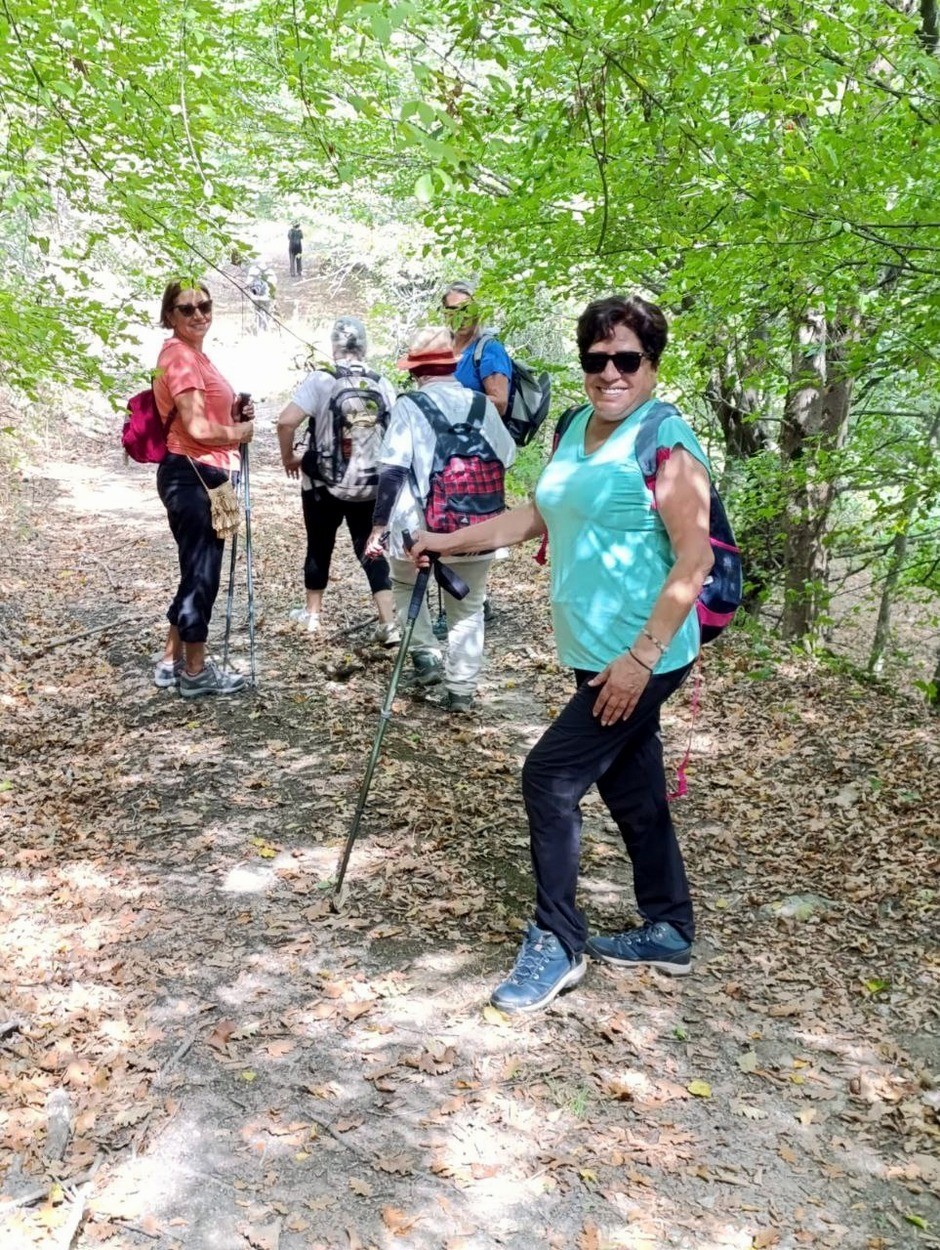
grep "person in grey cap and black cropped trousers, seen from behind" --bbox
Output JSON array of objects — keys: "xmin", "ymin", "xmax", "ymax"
[{"xmin": 278, "ymin": 316, "xmax": 401, "ymax": 646}]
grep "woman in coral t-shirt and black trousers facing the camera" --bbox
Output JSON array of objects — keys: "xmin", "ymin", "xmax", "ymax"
[{"xmin": 154, "ymin": 283, "xmax": 255, "ymax": 699}]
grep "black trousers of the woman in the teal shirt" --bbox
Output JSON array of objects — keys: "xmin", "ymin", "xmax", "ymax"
[{"xmin": 523, "ymin": 665, "xmax": 695, "ymax": 955}]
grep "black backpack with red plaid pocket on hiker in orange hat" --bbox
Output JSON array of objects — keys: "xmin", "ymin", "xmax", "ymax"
[{"xmin": 408, "ymin": 390, "xmax": 506, "ymax": 534}]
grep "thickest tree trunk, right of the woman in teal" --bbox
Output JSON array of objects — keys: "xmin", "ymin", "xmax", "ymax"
[{"xmin": 780, "ymin": 311, "xmax": 854, "ymax": 640}]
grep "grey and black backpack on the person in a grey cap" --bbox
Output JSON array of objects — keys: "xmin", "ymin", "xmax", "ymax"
[{"xmin": 301, "ymin": 363, "xmax": 390, "ymax": 503}]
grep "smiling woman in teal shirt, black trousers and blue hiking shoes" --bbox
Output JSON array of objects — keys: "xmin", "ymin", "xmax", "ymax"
[{"xmin": 413, "ymin": 296, "xmax": 713, "ymax": 1011}]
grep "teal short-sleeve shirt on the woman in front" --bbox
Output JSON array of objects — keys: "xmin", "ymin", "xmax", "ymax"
[{"xmin": 535, "ymin": 400, "xmax": 710, "ymax": 673}]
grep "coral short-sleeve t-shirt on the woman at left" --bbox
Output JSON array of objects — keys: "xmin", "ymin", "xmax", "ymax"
[{"xmin": 154, "ymin": 338, "xmax": 241, "ymax": 471}]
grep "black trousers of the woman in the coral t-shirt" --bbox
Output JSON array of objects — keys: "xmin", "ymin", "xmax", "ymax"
[{"xmin": 156, "ymin": 453, "xmax": 230, "ymax": 643}]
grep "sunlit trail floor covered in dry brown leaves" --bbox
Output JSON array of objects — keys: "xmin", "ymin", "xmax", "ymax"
[{"xmin": 0, "ymin": 439, "xmax": 940, "ymax": 1250}]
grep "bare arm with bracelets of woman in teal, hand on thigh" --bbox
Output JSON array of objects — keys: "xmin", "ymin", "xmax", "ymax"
[{"xmin": 590, "ymin": 448, "xmax": 714, "ymax": 725}]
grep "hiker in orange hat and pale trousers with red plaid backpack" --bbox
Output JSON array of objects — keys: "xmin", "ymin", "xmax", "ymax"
[{"xmin": 366, "ymin": 326, "xmax": 516, "ymax": 713}]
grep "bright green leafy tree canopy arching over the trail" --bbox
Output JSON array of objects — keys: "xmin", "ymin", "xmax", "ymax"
[{"xmin": 0, "ymin": 0, "xmax": 940, "ymax": 675}]
